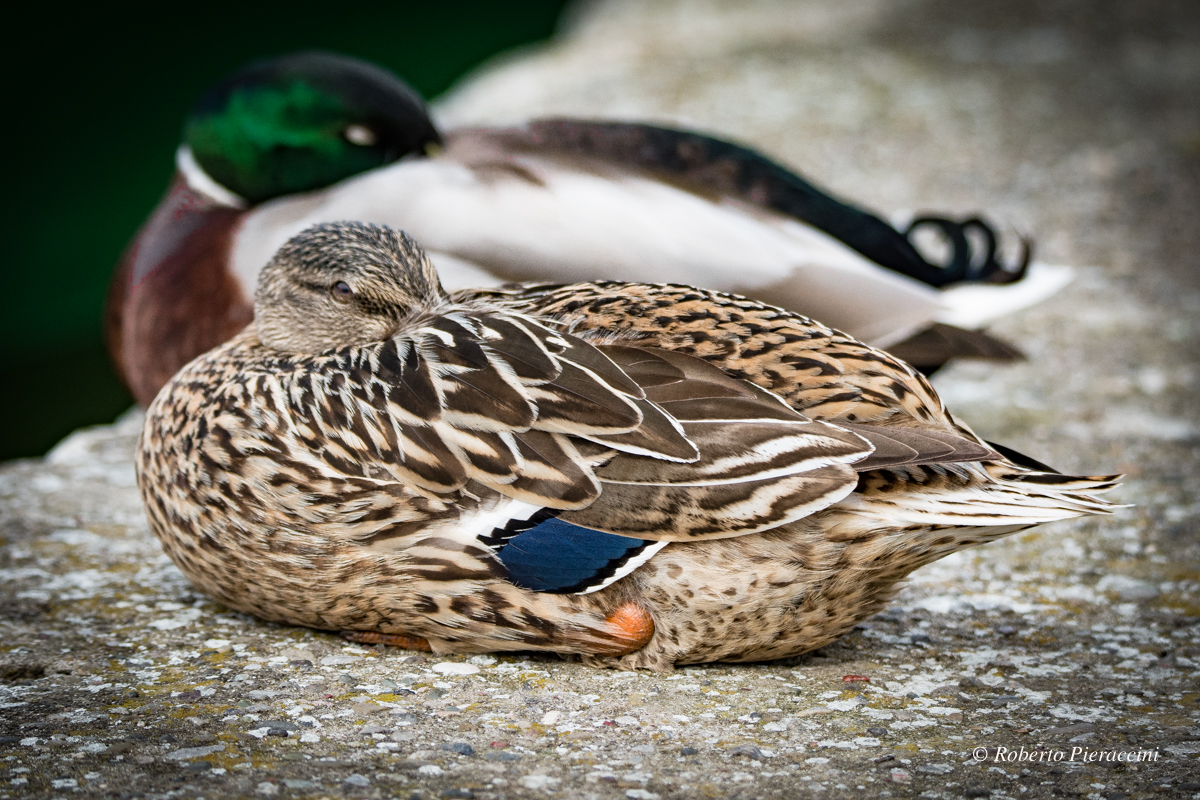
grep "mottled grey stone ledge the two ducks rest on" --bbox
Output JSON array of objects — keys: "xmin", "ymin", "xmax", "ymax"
[{"xmin": 0, "ymin": 0, "xmax": 1200, "ymax": 800}]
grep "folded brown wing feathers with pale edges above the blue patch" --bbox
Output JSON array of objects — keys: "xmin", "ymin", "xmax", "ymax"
[{"xmin": 322, "ymin": 309, "xmax": 883, "ymax": 532}]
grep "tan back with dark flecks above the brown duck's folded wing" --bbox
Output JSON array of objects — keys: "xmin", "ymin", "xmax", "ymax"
[{"xmin": 458, "ymin": 281, "xmax": 962, "ymax": 433}]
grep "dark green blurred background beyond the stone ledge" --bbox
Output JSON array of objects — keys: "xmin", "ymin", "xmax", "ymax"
[{"xmin": 0, "ymin": 0, "xmax": 565, "ymax": 459}]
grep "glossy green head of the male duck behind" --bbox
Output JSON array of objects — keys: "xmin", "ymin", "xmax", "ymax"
[{"xmin": 184, "ymin": 53, "xmax": 440, "ymax": 203}]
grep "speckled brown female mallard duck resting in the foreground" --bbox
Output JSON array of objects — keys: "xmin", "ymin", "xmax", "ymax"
[{"xmin": 138, "ymin": 223, "xmax": 1114, "ymax": 669}]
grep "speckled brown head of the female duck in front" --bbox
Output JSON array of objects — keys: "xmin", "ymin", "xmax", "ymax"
[{"xmin": 254, "ymin": 222, "xmax": 449, "ymax": 354}]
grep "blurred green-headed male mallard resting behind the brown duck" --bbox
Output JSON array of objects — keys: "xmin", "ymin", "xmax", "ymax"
[{"xmin": 106, "ymin": 53, "xmax": 1063, "ymax": 403}]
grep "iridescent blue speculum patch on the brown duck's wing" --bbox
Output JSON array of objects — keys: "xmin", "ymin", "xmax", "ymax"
[{"xmin": 496, "ymin": 517, "xmax": 658, "ymax": 594}]
